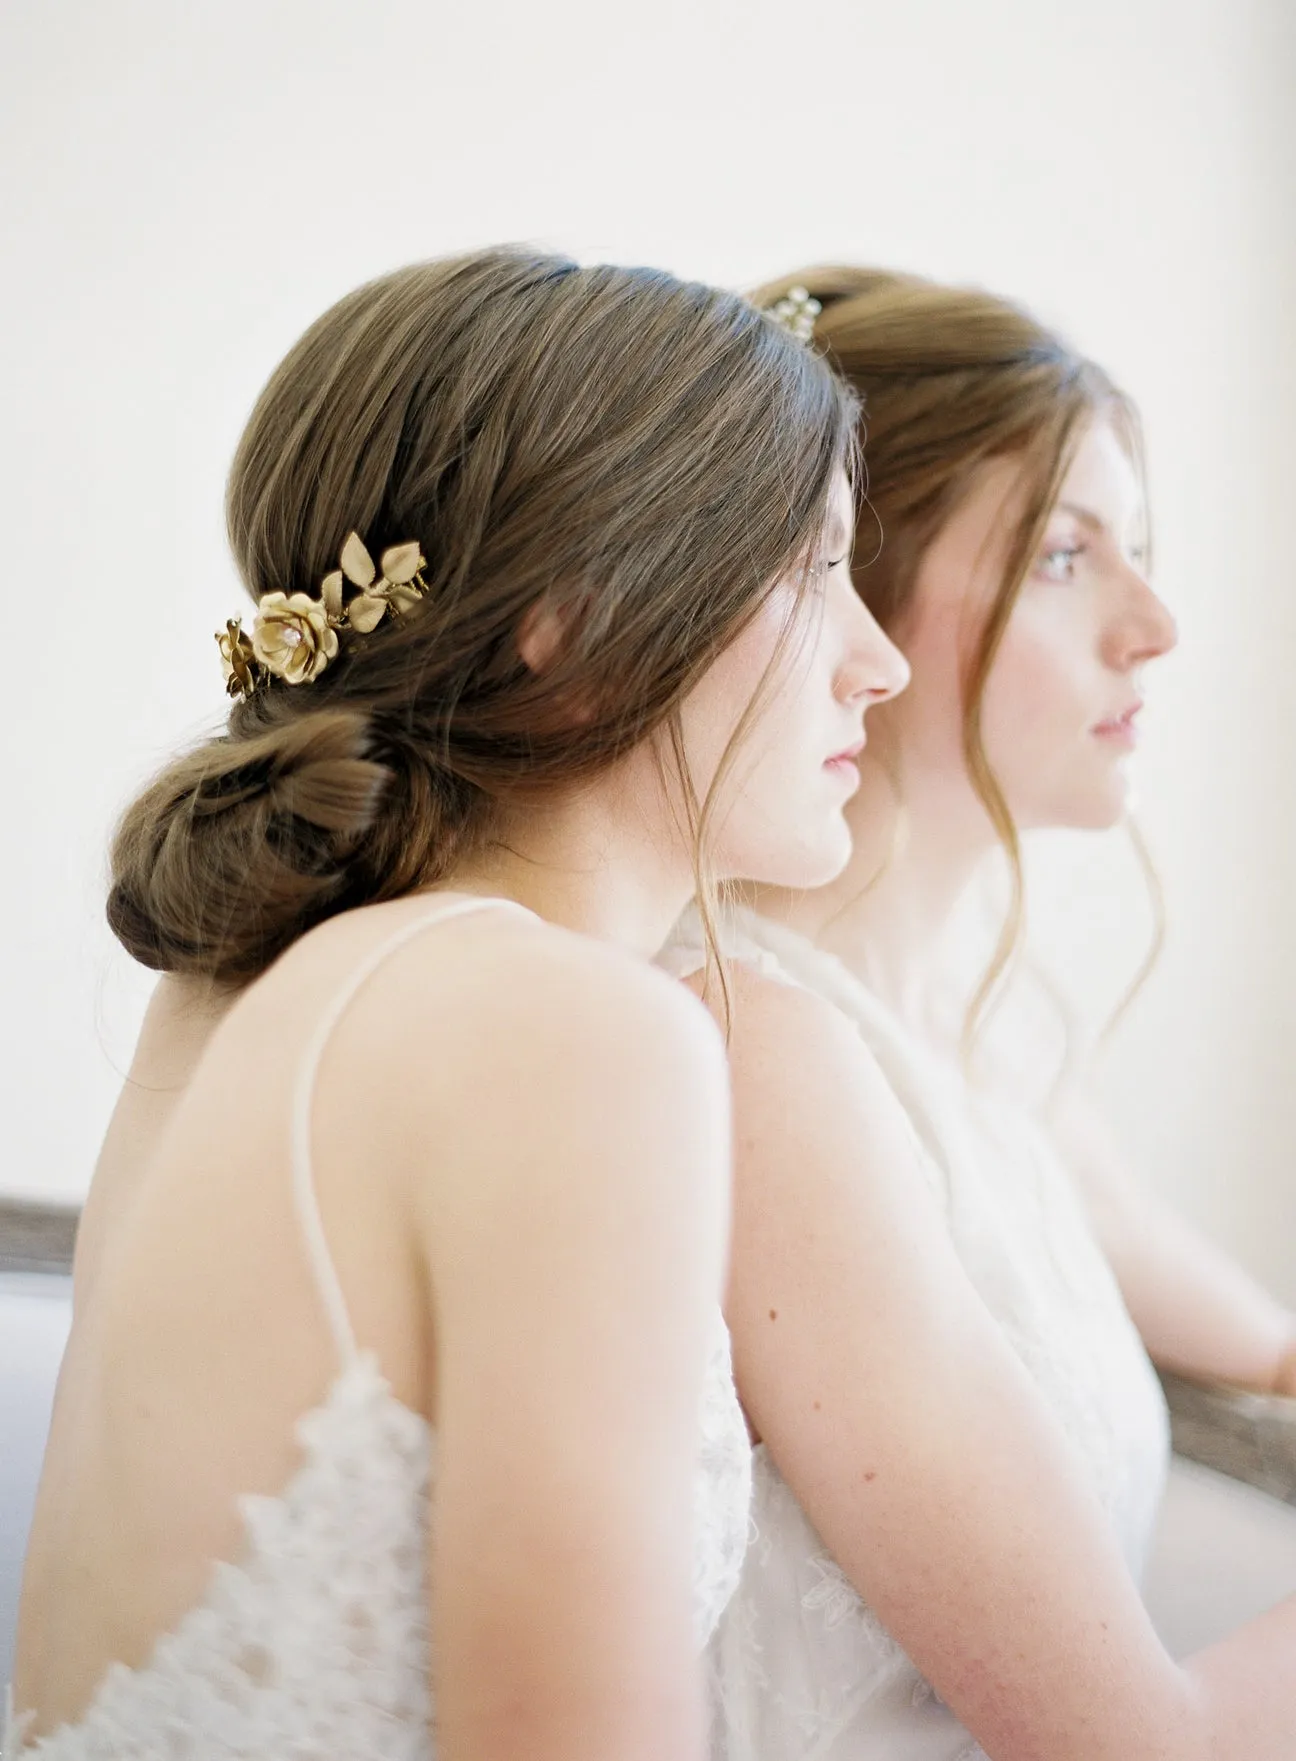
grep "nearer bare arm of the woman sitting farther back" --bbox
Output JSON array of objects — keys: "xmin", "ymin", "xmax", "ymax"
[{"xmin": 714, "ymin": 974, "xmax": 1296, "ymax": 1761}]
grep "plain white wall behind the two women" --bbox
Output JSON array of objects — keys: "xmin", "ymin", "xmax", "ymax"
[{"xmin": 0, "ymin": 0, "xmax": 1296, "ymax": 1300}]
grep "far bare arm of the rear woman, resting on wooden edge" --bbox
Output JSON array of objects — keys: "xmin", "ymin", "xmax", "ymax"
[{"xmin": 1053, "ymin": 1097, "xmax": 1296, "ymax": 1395}]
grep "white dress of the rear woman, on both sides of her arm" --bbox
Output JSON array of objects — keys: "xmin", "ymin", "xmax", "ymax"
[{"xmin": 664, "ymin": 912, "xmax": 1169, "ymax": 1761}]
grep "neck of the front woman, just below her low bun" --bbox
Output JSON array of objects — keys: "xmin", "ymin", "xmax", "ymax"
[{"xmin": 444, "ymin": 750, "xmax": 694, "ymax": 960}]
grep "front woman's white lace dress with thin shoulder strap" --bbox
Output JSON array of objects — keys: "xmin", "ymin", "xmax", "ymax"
[{"xmin": 0, "ymin": 900, "xmax": 752, "ymax": 1761}]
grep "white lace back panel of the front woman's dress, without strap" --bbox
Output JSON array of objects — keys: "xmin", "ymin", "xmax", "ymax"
[{"xmin": 5, "ymin": 1352, "xmax": 433, "ymax": 1761}]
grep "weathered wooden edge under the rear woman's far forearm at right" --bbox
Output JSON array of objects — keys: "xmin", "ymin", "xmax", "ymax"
[{"xmin": 1159, "ymin": 1370, "xmax": 1296, "ymax": 1504}]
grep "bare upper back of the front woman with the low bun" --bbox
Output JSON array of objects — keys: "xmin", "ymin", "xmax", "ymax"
[{"xmin": 16, "ymin": 898, "xmax": 732, "ymax": 1728}]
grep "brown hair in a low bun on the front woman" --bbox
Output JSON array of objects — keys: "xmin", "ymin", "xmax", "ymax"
[{"xmin": 107, "ymin": 250, "xmax": 858, "ymax": 981}]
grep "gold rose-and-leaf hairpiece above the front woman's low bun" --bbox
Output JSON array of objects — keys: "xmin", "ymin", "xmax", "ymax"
[{"xmin": 217, "ymin": 532, "xmax": 428, "ymax": 697}]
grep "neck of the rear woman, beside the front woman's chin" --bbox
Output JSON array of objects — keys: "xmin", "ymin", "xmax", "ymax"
[{"xmin": 748, "ymin": 748, "xmax": 997, "ymax": 1030}]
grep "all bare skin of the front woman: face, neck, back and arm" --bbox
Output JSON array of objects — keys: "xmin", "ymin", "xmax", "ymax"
[{"xmin": 14, "ymin": 491, "xmax": 896, "ymax": 1761}]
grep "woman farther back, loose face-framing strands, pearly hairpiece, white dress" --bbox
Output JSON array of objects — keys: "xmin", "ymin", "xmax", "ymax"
[{"xmin": 671, "ymin": 269, "xmax": 1296, "ymax": 1761}]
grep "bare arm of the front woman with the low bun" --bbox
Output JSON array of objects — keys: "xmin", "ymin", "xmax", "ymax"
[{"xmin": 405, "ymin": 932, "xmax": 731, "ymax": 1761}]
